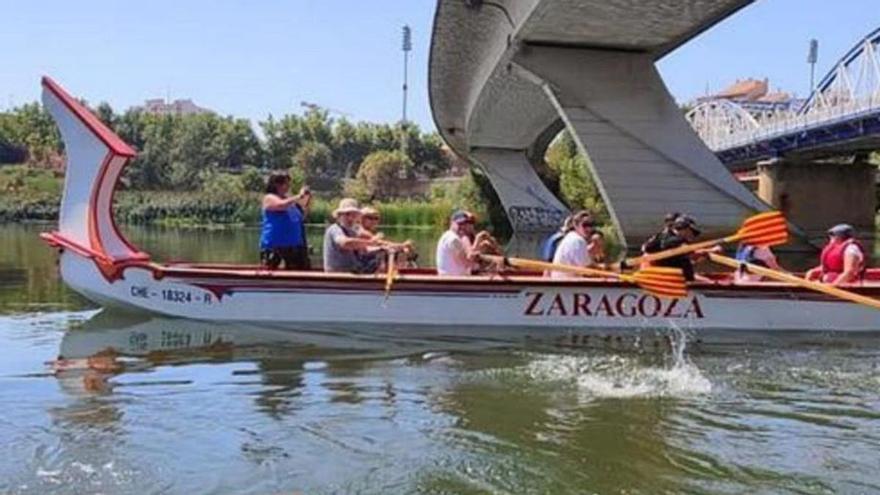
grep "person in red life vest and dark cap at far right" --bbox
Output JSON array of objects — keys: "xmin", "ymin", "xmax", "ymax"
[{"xmin": 806, "ymin": 223, "xmax": 866, "ymax": 285}]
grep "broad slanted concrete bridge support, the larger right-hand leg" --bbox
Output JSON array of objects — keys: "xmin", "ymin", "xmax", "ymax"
[{"xmin": 513, "ymin": 46, "xmax": 766, "ymax": 241}]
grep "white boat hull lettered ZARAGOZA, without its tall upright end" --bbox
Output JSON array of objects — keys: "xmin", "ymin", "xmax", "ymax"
[{"xmin": 60, "ymin": 251, "xmax": 880, "ymax": 337}]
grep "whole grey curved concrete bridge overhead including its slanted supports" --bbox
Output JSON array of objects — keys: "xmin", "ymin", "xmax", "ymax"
[{"xmin": 430, "ymin": 0, "xmax": 766, "ymax": 246}]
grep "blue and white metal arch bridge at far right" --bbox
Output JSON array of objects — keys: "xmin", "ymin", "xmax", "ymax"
[{"xmin": 687, "ymin": 29, "xmax": 880, "ymax": 170}]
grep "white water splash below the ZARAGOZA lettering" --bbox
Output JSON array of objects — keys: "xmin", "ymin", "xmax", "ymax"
[{"xmin": 525, "ymin": 329, "xmax": 712, "ymax": 400}]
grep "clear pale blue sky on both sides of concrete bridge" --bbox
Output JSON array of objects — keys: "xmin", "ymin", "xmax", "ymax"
[{"xmin": 0, "ymin": 0, "xmax": 880, "ymax": 130}]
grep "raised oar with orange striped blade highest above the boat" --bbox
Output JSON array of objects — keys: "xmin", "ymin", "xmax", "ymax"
[{"xmin": 621, "ymin": 211, "xmax": 788, "ymax": 268}]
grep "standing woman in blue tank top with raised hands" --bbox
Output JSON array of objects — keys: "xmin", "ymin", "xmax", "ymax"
[{"xmin": 260, "ymin": 172, "xmax": 311, "ymax": 270}]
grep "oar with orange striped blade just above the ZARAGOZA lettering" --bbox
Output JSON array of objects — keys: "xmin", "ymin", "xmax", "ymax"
[{"xmin": 481, "ymin": 254, "xmax": 687, "ymax": 297}]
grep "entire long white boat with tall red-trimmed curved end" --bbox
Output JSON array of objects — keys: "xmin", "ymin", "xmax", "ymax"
[{"xmin": 37, "ymin": 78, "xmax": 880, "ymax": 338}]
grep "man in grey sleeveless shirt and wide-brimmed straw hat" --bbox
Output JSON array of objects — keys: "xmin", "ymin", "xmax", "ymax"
[{"xmin": 324, "ymin": 198, "xmax": 380, "ymax": 274}]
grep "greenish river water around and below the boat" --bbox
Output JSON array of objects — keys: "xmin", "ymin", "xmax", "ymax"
[{"xmin": 0, "ymin": 226, "xmax": 880, "ymax": 494}]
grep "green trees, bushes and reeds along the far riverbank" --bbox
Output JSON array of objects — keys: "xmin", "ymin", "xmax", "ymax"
[{"xmin": 0, "ymin": 99, "xmax": 607, "ymax": 233}]
